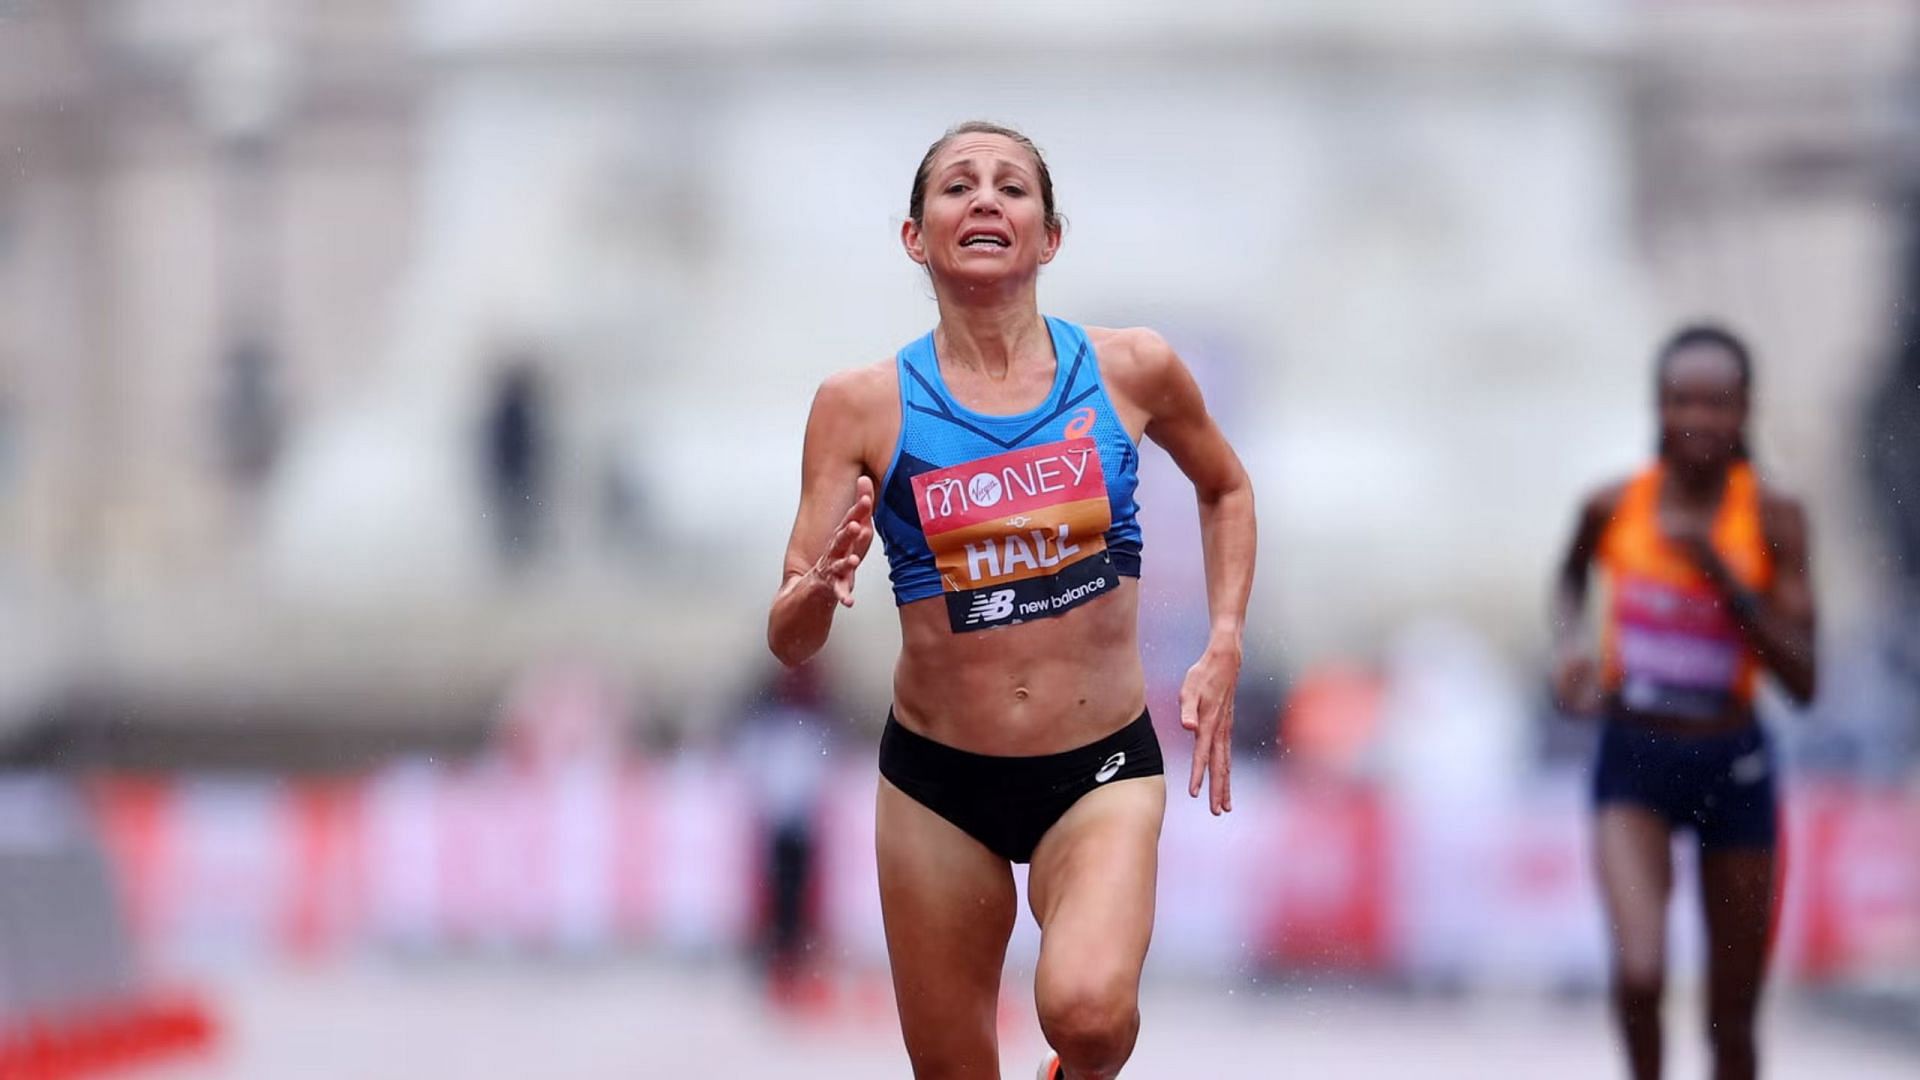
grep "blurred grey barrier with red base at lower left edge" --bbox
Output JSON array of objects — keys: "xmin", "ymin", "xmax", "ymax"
[{"xmin": 0, "ymin": 776, "xmax": 215, "ymax": 1080}]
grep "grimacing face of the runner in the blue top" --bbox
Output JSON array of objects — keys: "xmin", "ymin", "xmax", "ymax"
[{"xmin": 902, "ymin": 135, "xmax": 1060, "ymax": 284}]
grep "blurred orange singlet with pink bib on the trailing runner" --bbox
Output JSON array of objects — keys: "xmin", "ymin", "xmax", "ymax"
[{"xmin": 1599, "ymin": 461, "xmax": 1774, "ymax": 721}]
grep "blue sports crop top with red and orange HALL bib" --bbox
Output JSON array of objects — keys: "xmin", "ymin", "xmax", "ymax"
[{"xmin": 874, "ymin": 315, "xmax": 1140, "ymax": 632}]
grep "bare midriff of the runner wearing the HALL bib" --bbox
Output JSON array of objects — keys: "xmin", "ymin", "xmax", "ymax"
[{"xmin": 893, "ymin": 578, "xmax": 1146, "ymax": 757}]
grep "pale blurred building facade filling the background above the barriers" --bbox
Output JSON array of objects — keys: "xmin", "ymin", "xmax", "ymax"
[{"xmin": 0, "ymin": 0, "xmax": 1920, "ymax": 757}]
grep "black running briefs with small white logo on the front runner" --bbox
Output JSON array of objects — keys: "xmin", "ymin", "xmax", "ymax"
[{"xmin": 879, "ymin": 713, "xmax": 1165, "ymax": 863}]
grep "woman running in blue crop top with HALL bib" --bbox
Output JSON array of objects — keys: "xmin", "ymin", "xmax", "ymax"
[{"xmin": 768, "ymin": 123, "xmax": 1254, "ymax": 1080}]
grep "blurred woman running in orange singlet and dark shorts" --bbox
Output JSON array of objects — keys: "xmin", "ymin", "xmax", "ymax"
[{"xmin": 1555, "ymin": 327, "xmax": 1814, "ymax": 1080}]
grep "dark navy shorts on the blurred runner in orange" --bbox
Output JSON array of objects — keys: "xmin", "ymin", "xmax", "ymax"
[{"xmin": 1594, "ymin": 719, "xmax": 1778, "ymax": 847}]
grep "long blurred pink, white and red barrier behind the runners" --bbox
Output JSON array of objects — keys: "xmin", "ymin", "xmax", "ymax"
[{"xmin": 41, "ymin": 753, "xmax": 1920, "ymax": 988}]
